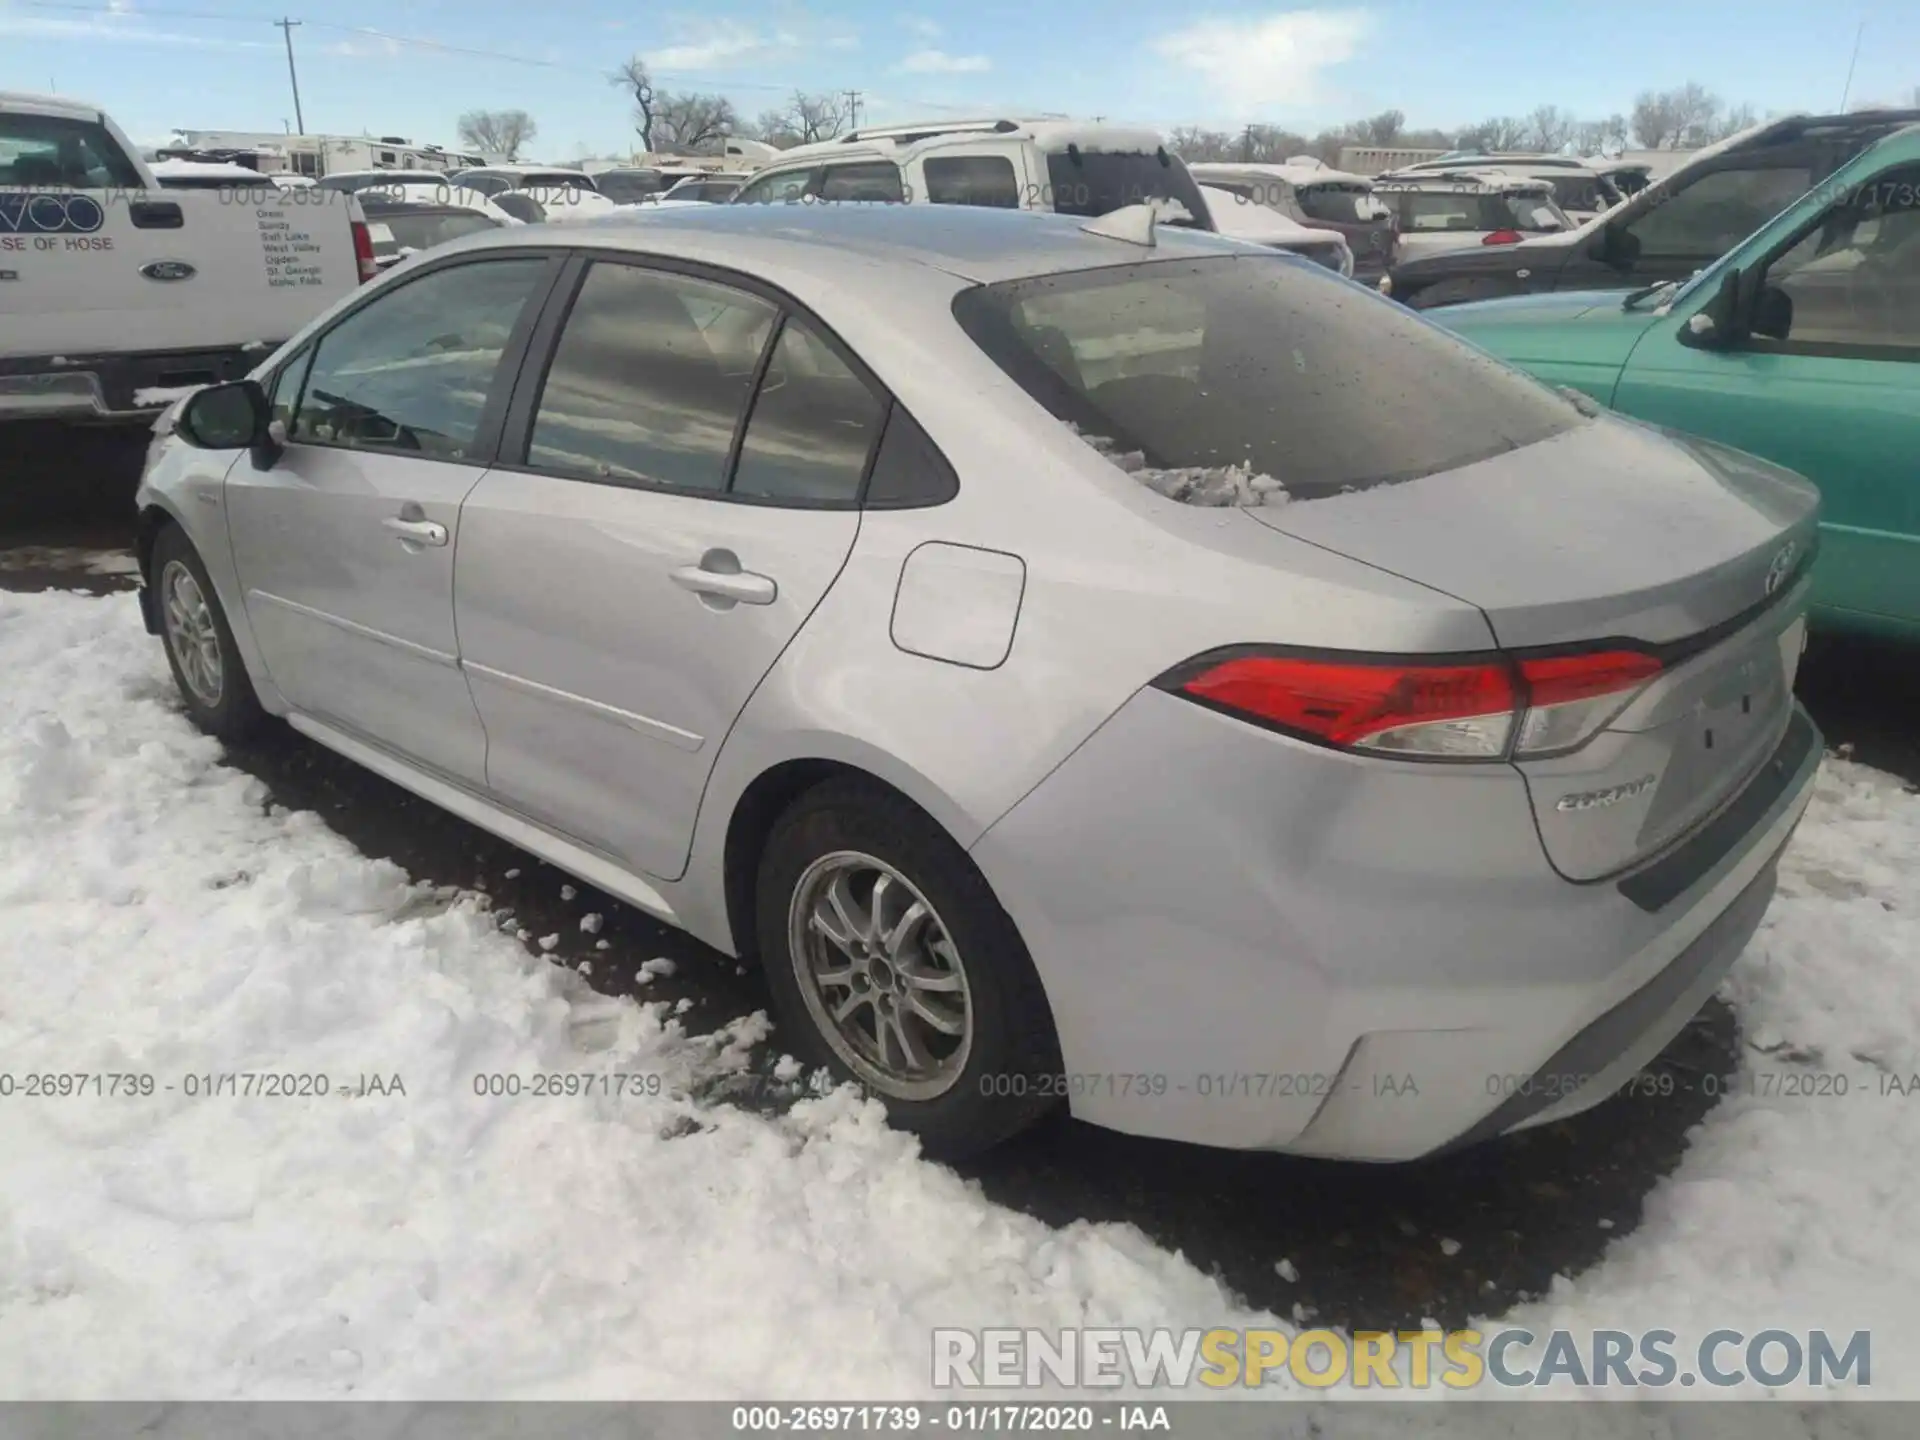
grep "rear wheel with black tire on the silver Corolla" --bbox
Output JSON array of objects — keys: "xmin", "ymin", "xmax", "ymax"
[{"xmin": 755, "ymin": 778, "xmax": 1062, "ymax": 1160}]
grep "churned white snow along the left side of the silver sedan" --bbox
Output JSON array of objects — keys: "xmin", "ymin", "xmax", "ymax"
[{"xmin": 0, "ymin": 593, "xmax": 1256, "ymax": 1398}]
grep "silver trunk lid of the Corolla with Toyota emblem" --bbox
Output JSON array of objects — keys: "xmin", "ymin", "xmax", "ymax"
[{"xmin": 1248, "ymin": 419, "xmax": 1818, "ymax": 881}]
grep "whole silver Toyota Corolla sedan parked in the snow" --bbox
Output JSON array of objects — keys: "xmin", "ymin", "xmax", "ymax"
[{"xmin": 138, "ymin": 205, "xmax": 1822, "ymax": 1160}]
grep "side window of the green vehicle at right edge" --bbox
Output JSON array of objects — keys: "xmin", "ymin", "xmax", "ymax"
[{"xmin": 1763, "ymin": 167, "xmax": 1920, "ymax": 357}]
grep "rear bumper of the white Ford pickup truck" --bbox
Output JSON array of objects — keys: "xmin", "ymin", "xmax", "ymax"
[{"xmin": 0, "ymin": 340, "xmax": 276, "ymax": 420}]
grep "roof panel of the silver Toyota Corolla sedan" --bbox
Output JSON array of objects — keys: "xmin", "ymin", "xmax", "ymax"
[{"xmin": 445, "ymin": 204, "xmax": 1246, "ymax": 284}]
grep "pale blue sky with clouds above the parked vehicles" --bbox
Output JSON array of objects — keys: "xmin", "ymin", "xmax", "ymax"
[{"xmin": 0, "ymin": 0, "xmax": 1920, "ymax": 159}]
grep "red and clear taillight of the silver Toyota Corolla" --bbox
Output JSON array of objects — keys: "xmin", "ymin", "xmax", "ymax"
[{"xmin": 1158, "ymin": 651, "xmax": 1661, "ymax": 760}]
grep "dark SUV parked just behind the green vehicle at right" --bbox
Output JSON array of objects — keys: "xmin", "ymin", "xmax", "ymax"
[{"xmin": 1390, "ymin": 109, "xmax": 1920, "ymax": 309}]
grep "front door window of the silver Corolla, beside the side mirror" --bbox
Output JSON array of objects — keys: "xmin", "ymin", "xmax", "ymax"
[{"xmin": 292, "ymin": 259, "xmax": 545, "ymax": 461}]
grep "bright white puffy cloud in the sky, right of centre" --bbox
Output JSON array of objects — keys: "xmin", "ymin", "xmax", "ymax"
[{"xmin": 1154, "ymin": 10, "xmax": 1373, "ymax": 111}]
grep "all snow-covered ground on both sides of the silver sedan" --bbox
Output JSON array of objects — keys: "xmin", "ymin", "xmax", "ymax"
[{"xmin": 0, "ymin": 593, "xmax": 1920, "ymax": 1432}]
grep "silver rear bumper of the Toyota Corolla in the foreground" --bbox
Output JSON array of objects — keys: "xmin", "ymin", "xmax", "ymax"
[{"xmin": 973, "ymin": 691, "xmax": 1822, "ymax": 1160}]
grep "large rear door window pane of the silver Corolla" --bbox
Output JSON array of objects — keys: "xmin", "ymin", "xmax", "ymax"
[{"xmin": 526, "ymin": 265, "xmax": 778, "ymax": 492}]
